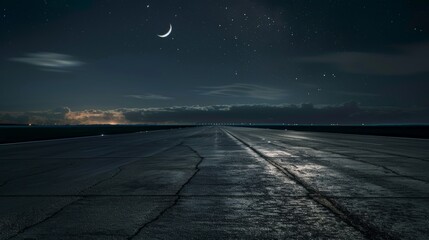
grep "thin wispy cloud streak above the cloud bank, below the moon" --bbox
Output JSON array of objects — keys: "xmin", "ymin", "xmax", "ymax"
[{"xmin": 199, "ymin": 83, "xmax": 286, "ymax": 100}]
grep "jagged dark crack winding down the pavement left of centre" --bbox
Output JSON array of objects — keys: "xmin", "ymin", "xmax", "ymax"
[{"xmin": 127, "ymin": 144, "xmax": 204, "ymax": 240}]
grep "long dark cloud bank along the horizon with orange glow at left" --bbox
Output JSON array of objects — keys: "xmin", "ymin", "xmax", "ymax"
[{"xmin": 0, "ymin": 102, "xmax": 429, "ymax": 124}]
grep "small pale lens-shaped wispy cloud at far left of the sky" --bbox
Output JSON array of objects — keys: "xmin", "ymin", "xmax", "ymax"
[{"xmin": 10, "ymin": 52, "xmax": 83, "ymax": 72}]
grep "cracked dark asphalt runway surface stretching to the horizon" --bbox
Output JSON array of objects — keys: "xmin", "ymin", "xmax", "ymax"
[{"xmin": 0, "ymin": 127, "xmax": 429, "ymax": 239}]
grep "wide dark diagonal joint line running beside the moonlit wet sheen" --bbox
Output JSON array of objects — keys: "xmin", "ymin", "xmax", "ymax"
[{"xmin": 222, "ymin": 129, "xmax": 398, "ymax": 240}]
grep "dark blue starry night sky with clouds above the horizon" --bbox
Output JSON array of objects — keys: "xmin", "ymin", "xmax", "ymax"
[{"xmin": 0, "ymin": 0, "xmax": 429, "ymax": 124}]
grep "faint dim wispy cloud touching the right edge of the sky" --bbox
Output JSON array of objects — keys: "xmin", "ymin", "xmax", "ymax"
[{"xmin": 302, "ymin": 42, "xmax": 429, "ymax": 75}]
